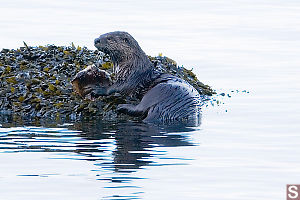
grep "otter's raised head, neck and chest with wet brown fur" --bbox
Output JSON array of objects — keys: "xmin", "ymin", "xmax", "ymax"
[{"xmin": 95, "ymin": 32, "xmax": 160, "ymax": 97}]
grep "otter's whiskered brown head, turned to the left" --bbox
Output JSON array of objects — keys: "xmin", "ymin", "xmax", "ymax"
[{"xmin": 95, "ymin": 31, "xmax": 146, "ymax": 64}]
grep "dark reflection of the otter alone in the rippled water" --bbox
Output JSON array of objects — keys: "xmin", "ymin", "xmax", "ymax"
[{"xmin": 75, "ymin": 121, "xmax": 199, "ymax": 172}]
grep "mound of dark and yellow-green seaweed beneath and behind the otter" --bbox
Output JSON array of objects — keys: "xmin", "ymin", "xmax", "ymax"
[{"xmin": 0, "ymin": 42, "xmax": 214, "ymax": 120}]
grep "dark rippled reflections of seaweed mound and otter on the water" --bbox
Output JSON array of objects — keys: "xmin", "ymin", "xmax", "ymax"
[{"xmin": 0, "ymin": 121, "xmax": 195, "ymax": 199}]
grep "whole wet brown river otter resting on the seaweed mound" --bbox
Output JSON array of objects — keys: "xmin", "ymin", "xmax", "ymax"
[{"xmin": 93, "ymin": 31, "xmax": 201, "ymax": 122}]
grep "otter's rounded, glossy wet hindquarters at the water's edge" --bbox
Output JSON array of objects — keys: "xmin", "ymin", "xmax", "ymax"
[{"xmin": 142, "ymin": 74, "xmax": 202, "ymax": 122}]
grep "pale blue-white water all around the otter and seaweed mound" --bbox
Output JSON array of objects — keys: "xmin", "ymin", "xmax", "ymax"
[{"xmin": 0, "ymin": 0, "xmax": 300, "ymax": 200}]
